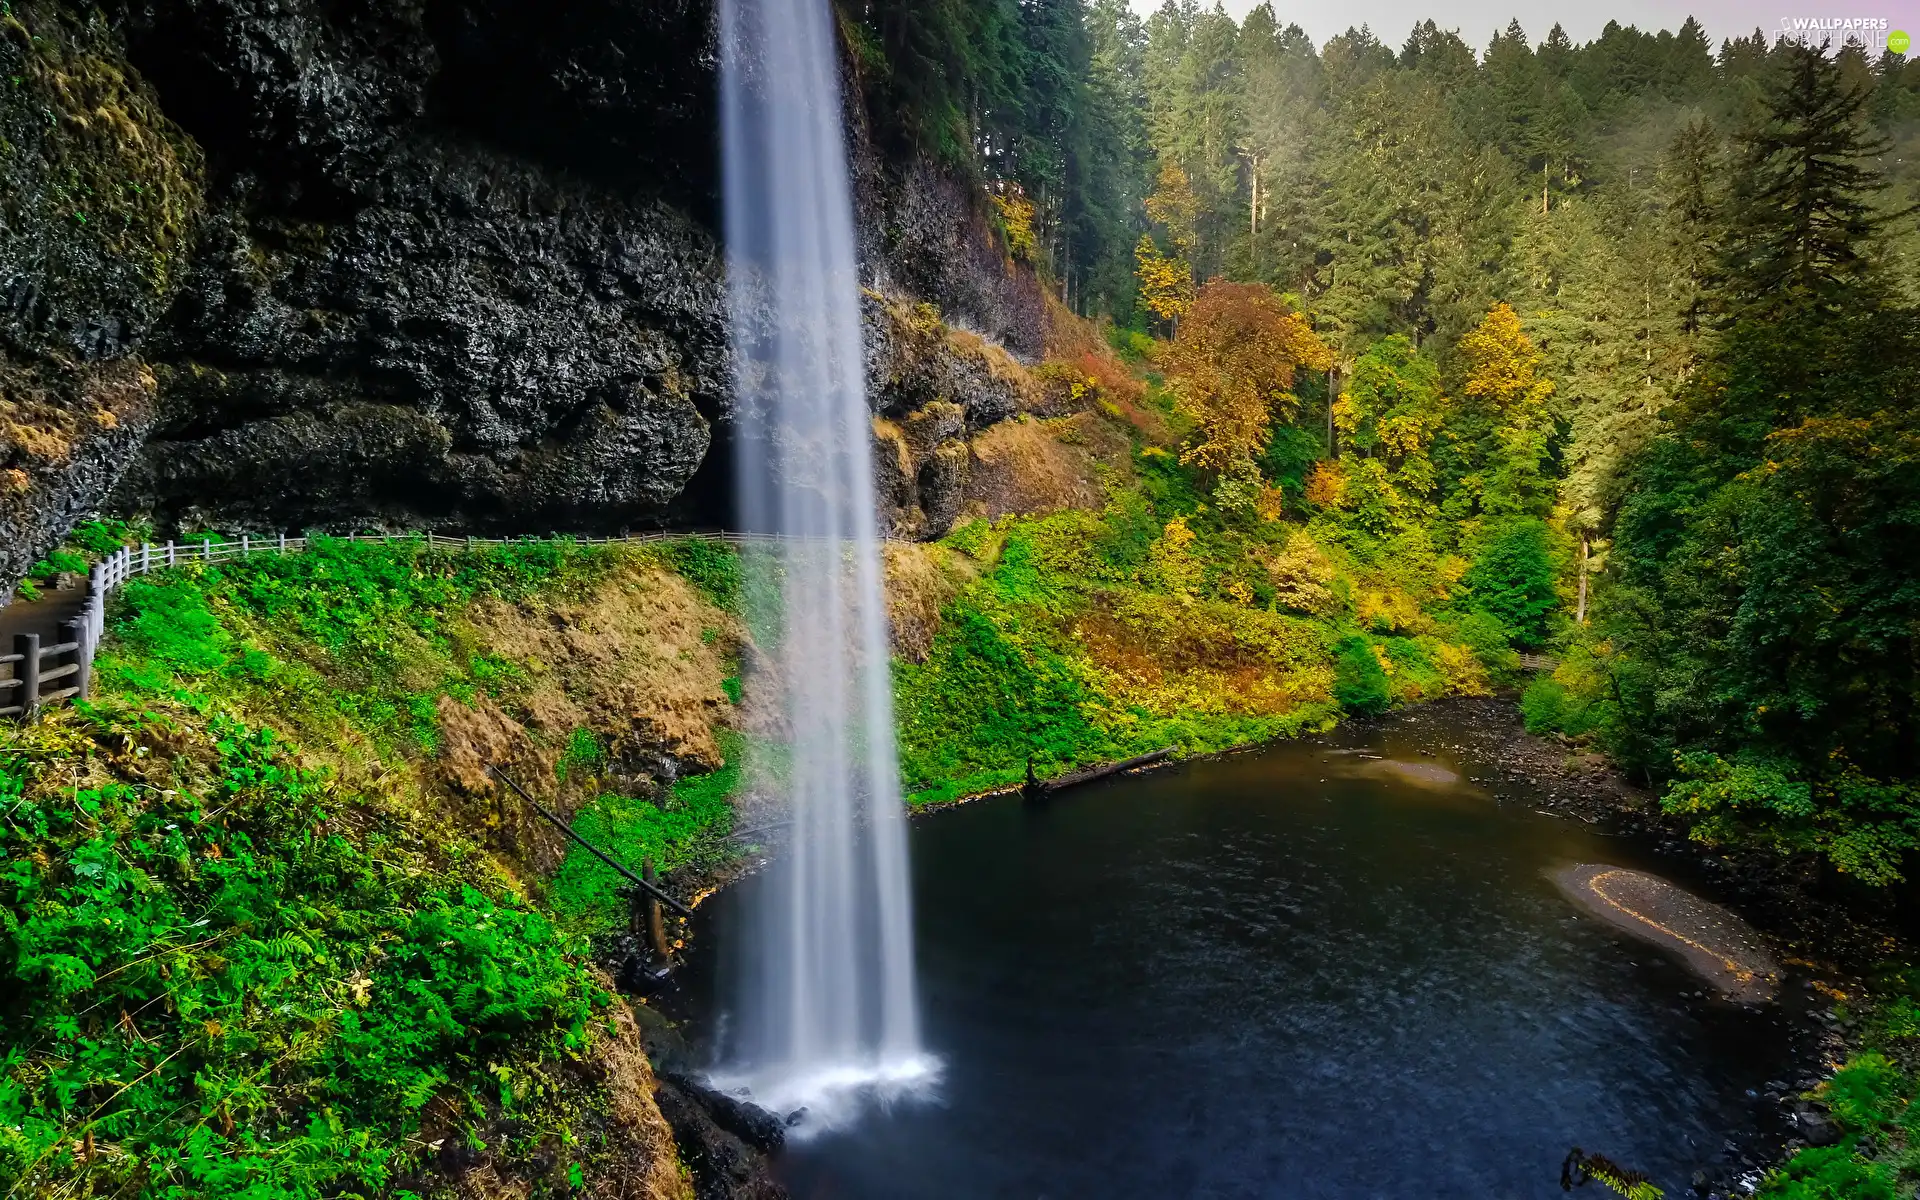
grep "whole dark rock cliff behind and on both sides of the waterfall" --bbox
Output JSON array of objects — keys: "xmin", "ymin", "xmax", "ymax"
[{"xmin": 0, "ymin": 0, "xmax": 1044, "ymax": 584}]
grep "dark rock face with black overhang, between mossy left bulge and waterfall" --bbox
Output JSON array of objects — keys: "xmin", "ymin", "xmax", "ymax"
[{"xmin": 103, "ymin": 0, "xmax": 728, "ymax": 532}]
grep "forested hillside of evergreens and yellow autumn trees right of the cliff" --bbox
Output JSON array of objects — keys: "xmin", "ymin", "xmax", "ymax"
[{"xmin": 849, "ymin": 0, "xmax": 1920, "ymax": 883}]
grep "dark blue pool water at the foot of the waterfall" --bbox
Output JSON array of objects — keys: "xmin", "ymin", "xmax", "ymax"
[{"xmin": 687, "ymin": 710, "xmax": 1788, "ymax": 1200}]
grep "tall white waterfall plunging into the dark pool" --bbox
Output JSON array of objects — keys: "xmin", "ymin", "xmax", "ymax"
[{"xmin": 716, "ymin": 0, "xmax": 931, "ymax": 1125}]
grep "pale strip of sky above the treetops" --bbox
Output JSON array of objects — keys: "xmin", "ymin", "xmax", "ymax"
[{"xmin": 1131, "ymin": 0, "xmax": 1920, "ymax": 56}]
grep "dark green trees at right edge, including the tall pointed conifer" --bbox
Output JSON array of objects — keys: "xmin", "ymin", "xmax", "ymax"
[{"xmin": 1530, "ymin": 52, "xmax": 1920, "ymax": 883}]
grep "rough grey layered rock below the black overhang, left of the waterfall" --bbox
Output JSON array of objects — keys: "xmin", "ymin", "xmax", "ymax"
[{"xmin": 117, "ymin": 140, "xmax": 728, "ymax": 532}]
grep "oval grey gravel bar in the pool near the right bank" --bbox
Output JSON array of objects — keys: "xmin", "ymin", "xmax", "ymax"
[{"xmin": 1551, "ymin": 862, "xmax": 1780, "ymax": 1002}]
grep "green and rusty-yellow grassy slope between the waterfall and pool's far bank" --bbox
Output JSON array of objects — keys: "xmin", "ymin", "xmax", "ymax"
[{"xmin": 895, "ymin": 407, "xmax": 1515, "ymax": 803}]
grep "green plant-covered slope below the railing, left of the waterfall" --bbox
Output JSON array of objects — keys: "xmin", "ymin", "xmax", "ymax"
[{"xmin": 0, "ymin": 526, "xmax": 764, "ymax": 1200}]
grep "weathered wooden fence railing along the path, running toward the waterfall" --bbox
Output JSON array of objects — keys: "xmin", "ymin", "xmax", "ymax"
[{"xmin": 0, "ymin": 532, "xmax": 764, "ymax": 720}]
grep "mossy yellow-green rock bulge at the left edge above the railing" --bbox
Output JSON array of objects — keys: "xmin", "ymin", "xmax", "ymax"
[{"xmin": 0, "ymin": 0, "xmax": 202, "ymax": 591}]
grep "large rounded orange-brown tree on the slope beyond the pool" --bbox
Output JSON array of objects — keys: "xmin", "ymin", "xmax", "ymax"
[{"xmin": 1160, "ymin": 280, "xmax": 1332, "ymax": 478}]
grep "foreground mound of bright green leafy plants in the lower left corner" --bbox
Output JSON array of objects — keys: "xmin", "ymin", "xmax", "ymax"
[{"xmin": 0, "ymin": 699, "xmax": 607, "ymax": 1200}]
